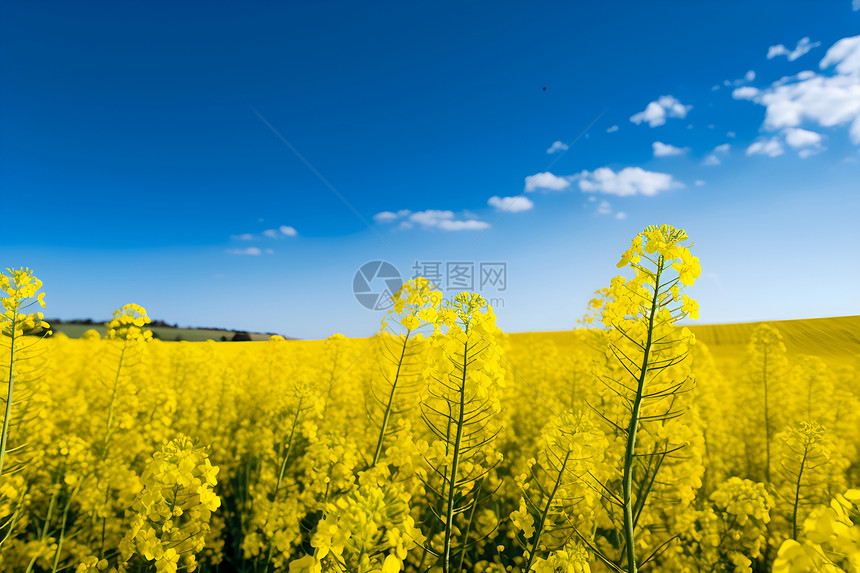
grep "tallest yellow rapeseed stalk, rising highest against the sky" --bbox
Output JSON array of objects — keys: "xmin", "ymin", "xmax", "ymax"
[{"xmin": 590, "ymin": 225, "xmax": 701, "ymax": 573}]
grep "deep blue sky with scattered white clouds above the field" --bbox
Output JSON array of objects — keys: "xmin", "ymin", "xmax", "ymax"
[{"xmin": 0, "ymin": 0, "xmax": 860, "ymax": 338}]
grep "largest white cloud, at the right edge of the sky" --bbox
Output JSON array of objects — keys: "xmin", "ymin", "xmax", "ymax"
[{"xmin": 735, "ymin": 36, "xmax": 860, "ymax": 145}]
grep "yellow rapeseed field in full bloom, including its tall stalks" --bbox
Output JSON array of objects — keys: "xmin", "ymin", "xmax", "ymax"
[{"xmin": 0, "ymin": 225, "xmax": 860, "ymax": 573}]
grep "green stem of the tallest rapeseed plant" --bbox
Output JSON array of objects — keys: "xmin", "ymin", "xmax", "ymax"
[{"xmin": 621, "ymin": 255, "xmax": 663, "ymax": 573}]
